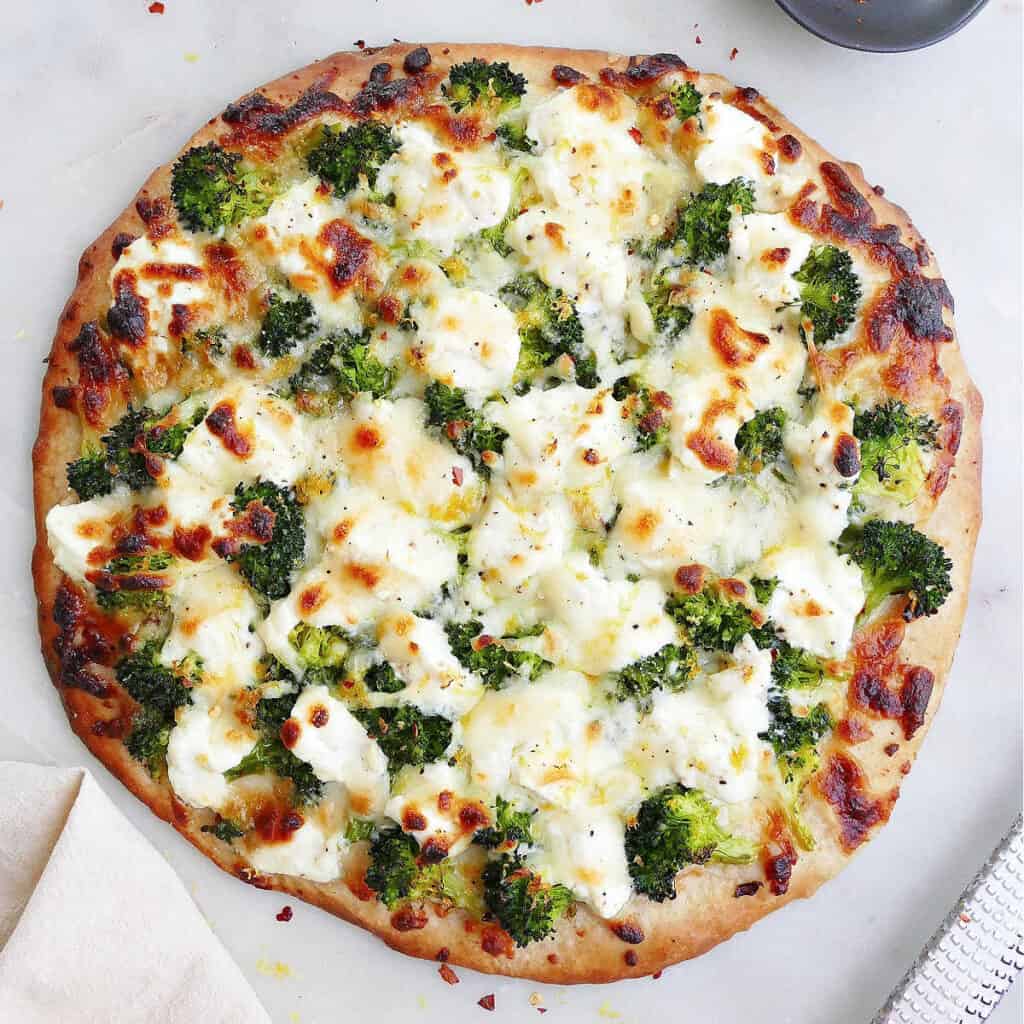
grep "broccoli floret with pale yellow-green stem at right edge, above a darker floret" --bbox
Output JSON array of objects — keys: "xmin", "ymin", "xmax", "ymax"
[{"xmin": 853, "ymin": 399, "xmax": 939, "ymax": 505}]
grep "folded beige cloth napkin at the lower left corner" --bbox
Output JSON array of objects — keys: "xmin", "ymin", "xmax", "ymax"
[{"xmin": 0, "ymin": 761, "xmax": 269, "ymax": 1024}]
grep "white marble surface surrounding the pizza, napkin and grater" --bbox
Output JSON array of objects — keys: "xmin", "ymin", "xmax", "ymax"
[{"xmin": 0, "ymin": 0, "xmax": 1021, "ymax": 1024}]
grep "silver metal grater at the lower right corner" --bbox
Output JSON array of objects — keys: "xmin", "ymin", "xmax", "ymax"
[{"xmin": 871, "ymin": 815, "xmax": 1024, "ymax": 1024}]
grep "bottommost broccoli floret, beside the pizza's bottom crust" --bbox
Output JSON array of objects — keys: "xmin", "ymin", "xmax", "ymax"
[{"xmin": 483, "ymin": 853, "xmax": 574, "ymax": 946}]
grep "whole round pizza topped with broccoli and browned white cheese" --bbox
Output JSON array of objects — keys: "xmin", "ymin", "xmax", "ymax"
[{"xmin": 34, "ymin": 44, "xmax": 981, "ymax": 983}]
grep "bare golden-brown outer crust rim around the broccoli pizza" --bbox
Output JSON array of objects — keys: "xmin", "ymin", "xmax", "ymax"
[{"xmin": 33, "ymin": 43, "xmax": 982, "ymax": 984}]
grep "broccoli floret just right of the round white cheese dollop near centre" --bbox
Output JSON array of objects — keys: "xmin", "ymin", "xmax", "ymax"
[{"xmin": 498, "ymin": 273, "xmax": 598, "ymax": 388}]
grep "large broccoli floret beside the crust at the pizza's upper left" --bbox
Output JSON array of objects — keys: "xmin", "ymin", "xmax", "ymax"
[{"xmin": 171, "ymin": 142, "xmax": 274, "ymax": 231}]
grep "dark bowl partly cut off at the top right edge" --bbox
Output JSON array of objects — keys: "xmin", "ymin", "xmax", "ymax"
[{"xmin": 776, "ymin": 0, "xmax": 988, "ymax": 53}]
